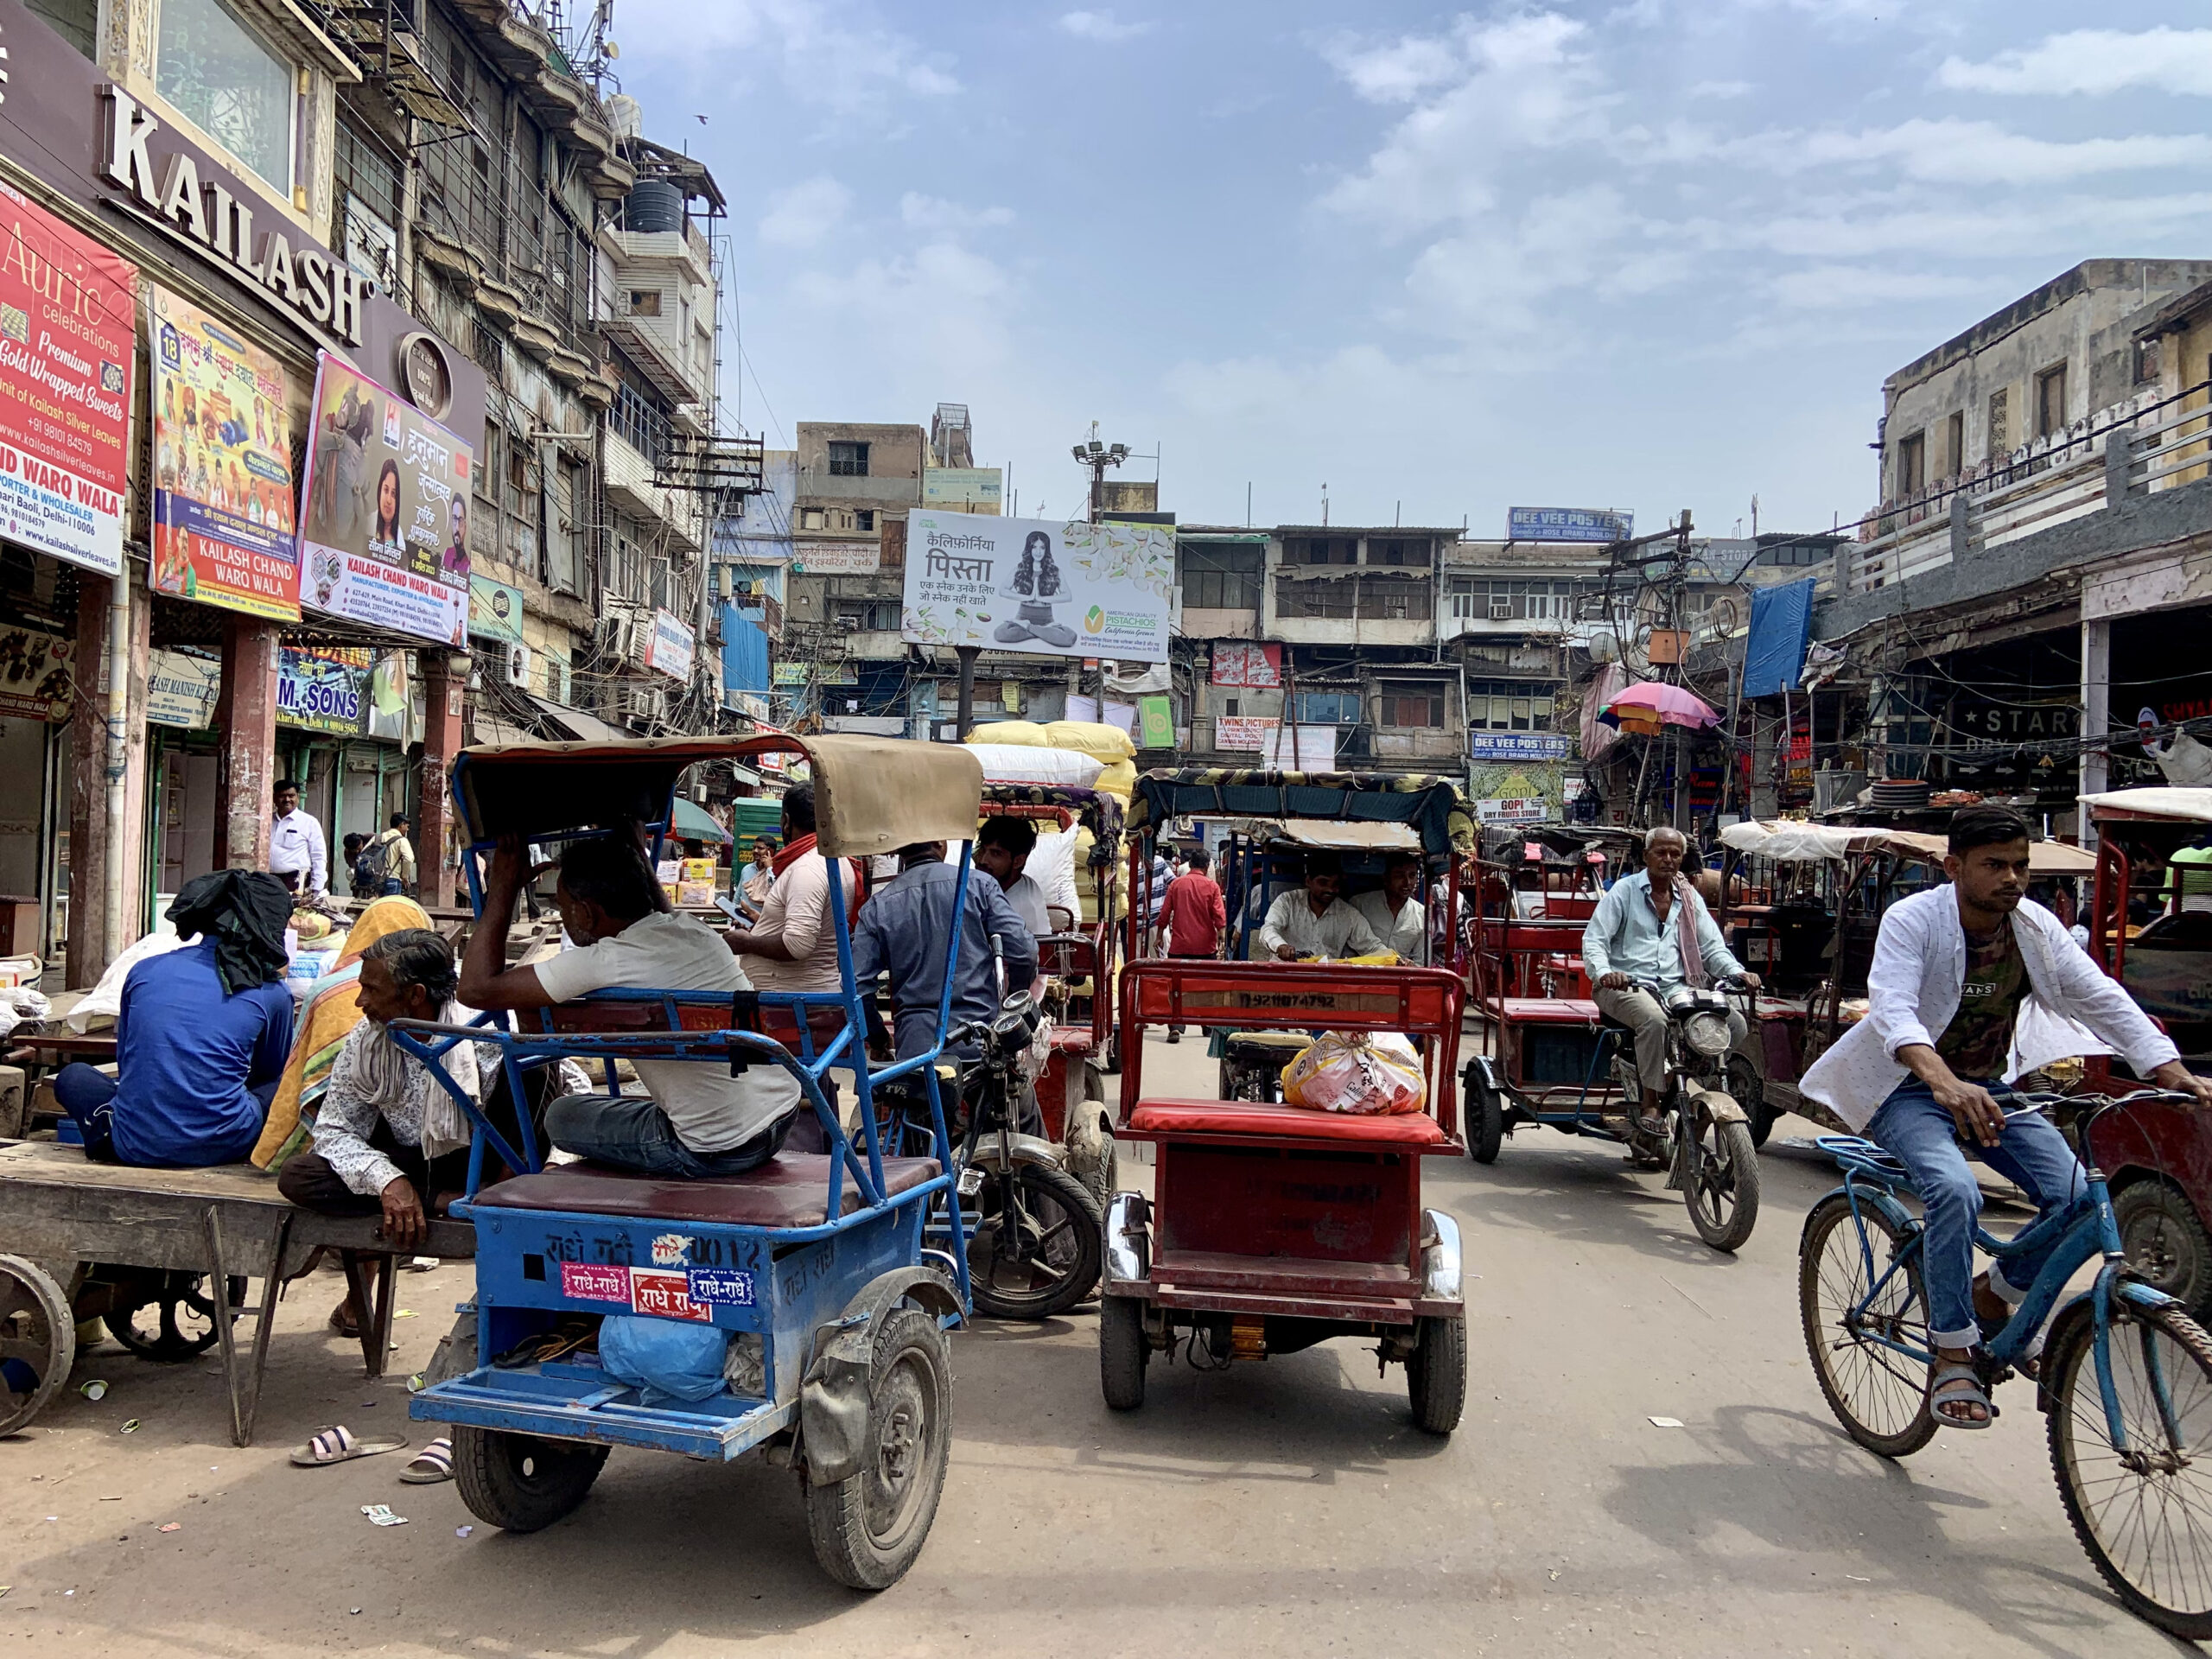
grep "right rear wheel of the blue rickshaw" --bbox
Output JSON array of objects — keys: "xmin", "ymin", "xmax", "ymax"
[{"xmin": 801, "ymin": 1307, "xmax": 953, "ymax": 1591}]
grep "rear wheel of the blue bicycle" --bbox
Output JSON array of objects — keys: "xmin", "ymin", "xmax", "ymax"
[{"xmin": 1798, "ymin": 1192, "xmax": 1936, "ymax": 1458}]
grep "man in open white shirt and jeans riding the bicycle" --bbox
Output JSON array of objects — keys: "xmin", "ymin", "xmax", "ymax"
[{"xmin": 1802, "ymin": 805, "xmax": 2212, "ymax": 1429}]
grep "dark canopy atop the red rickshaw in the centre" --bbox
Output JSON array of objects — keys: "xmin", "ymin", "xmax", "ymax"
[{"xmin": 1128, "ymin": 767, "xmax": 1476, "ymax": 858}]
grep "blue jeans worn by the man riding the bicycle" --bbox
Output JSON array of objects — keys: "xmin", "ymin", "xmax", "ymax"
[{"xmin": 1867, "ymin": 1077, "xmax": 2086, "ymax": 1347}]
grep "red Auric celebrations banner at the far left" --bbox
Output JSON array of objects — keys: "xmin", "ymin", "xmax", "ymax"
[{"xmin": 0, "ymin": 186, "xmax": 137, "ymax": 575}]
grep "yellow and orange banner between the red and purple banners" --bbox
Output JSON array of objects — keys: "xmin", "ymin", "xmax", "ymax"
[{"xmin": 146, "ymin": 288, "xmax": 299, "ymax": 621}]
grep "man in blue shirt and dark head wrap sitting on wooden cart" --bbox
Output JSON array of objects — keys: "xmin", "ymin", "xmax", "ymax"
[{"xmin": 53, "ymin": 869, "xmax": 292, "ymax": 1170}]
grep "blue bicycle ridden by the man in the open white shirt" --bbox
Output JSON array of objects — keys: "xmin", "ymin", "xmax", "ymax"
[{"xmin": 1798, "ymin": 1089, "xmax": 2212, "ymax": 1642}]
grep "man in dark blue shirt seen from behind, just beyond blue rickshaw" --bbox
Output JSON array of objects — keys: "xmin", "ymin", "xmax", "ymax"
[{"xmin": 852, "ymin": 841, "xmax": 1038, "ymax": 1059}]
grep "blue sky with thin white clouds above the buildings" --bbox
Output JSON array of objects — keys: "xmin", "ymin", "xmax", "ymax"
[{"xmin": 611, "ymin": 0, "xmax": 2212, "ymax": 537}]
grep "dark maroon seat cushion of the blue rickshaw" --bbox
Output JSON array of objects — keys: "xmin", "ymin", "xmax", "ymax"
[{"xmin": 475, "ymin": 1153, "xmax": 938, "ymax": 1228}]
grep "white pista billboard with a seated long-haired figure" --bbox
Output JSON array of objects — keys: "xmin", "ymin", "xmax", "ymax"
[{"xmin": 900, "ymin": 511, "xmax": 1174, "ymax": 661}]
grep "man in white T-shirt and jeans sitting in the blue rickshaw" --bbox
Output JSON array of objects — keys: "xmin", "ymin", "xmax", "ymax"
[{"xmin": 460, "ymin": 832, "xmax": 798, "ymax": 1179}]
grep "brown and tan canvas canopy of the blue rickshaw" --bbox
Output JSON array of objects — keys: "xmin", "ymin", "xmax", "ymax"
[{"xmin": 454, "ymin": 732, "xmax": 982, "ymax": 858}]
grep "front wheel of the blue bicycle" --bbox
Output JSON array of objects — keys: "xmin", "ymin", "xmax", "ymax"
[{"xmin": 2044, "ymin": 1299, "xmax": 2212, "ymax": 1642}]
